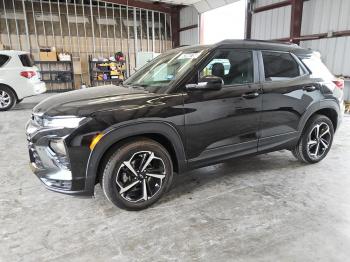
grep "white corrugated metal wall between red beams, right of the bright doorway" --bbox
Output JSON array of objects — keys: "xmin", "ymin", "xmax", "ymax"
[{"xmin": 252, "ymin": 0, "xmax": 350, "ymax": 77}]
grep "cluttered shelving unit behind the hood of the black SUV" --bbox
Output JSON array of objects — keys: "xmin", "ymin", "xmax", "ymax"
[{"xmin": 89, "ymin": 55, "xmax": 125, "ymax": 86}]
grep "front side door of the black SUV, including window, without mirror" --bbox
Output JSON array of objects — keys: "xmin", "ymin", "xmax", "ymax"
[{"xmin": 184, "ymin": 49, "xmax": 262, "ymax": 166}]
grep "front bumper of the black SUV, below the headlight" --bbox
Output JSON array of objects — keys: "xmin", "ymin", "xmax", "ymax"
[{"xmin": 26, "ymin": 117, "xmax": 93, "ymax": 196}]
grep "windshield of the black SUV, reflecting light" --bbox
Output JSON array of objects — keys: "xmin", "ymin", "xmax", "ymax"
[{"xmin": 124, "ymin": 47, "xmax": 207, "ymax": 92}]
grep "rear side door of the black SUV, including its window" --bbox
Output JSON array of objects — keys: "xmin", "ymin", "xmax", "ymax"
[{"xmin": 258, "ymin": 51, "xmax": 320, "ymax": 151}]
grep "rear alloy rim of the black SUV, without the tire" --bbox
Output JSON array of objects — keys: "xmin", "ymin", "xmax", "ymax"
[{"xmin": 307, "ymin": 122, "xmax": 332, "ymax": 160}]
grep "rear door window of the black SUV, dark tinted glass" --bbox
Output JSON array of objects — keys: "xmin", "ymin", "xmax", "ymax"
[{"xmin": 262, "ymin": 51, "xmax": 304, "ymax": 81}]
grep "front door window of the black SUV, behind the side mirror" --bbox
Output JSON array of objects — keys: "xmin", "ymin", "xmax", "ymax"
[{"xmin": 199, "ymin": 49, "xmax": 254, "ymax": 86}]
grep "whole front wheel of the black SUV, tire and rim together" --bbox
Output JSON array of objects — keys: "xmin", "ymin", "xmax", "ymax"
[{"xmin": 101, "ymin": 139, "xmax": 173, "ymax": 210}]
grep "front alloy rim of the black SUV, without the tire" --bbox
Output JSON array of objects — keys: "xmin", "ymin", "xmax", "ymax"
[{"xmin": 116, "ymin": 151, "xmax": 166, "ymax": 202}]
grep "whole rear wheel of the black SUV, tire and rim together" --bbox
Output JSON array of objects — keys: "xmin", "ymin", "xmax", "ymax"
[{"xmin": 292, "ymin": 115, "xmax": 334, "ymax": 164}]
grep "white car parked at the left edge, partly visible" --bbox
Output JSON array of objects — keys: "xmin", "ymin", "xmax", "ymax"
[{"xmin": 0, "ymin": 50, "xmax": 46, "ymax": 111}]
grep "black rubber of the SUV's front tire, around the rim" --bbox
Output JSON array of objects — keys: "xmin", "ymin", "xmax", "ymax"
[{"xmin": 102, "ymin": 140, "xmax": 173, "ymax": 210}]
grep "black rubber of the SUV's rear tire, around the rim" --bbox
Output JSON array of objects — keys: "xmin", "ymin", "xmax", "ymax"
[{"xmin": 301, "ymin": 115, "xmax": 334, "ymax": 163}]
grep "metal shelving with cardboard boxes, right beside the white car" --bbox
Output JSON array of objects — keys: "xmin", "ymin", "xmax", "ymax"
[{"xmin": 34, "ymin": 61, "xmax": 74, "ymax": 92}]
